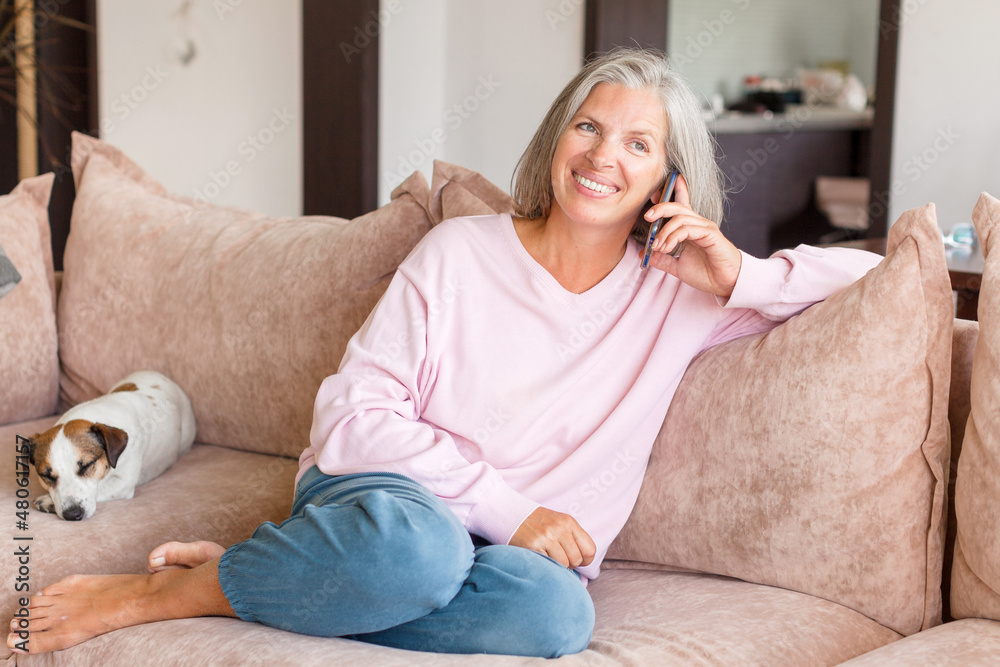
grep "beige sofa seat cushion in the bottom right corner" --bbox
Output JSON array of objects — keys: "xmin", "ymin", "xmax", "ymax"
[{"xmin": 845, "ymin": 618, "xmax": 1000, "ymax": 667}]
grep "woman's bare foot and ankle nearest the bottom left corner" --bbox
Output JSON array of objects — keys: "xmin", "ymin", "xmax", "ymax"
[{"xmin": 7, "ymin": 556, "xmax": 236, "ymax": 653}]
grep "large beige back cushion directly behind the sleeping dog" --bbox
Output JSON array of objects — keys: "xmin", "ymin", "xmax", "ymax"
[{"xmin": 59, "ymin": 134, "xmax": 430, "ymax": 456}]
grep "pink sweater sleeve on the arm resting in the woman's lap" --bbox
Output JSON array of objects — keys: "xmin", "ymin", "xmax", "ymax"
[{"xmin": 310, "ymin": 271, "xmax": 538, "ymax": 544}]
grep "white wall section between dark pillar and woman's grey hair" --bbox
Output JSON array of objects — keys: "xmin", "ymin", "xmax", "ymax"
[{"xmin": 379, "ymin": 0, "xmax": 584, "ymax": 203}]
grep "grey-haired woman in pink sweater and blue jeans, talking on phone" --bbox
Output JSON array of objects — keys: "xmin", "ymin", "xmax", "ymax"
[{"xmin": 8, "ymin": 51, "xmax": 878, "ymax": 656}]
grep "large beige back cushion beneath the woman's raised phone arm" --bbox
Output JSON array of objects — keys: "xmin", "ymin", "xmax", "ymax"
[{"xmin": 609, "ymin": 205, "xmax": 953, "ymax": 635}]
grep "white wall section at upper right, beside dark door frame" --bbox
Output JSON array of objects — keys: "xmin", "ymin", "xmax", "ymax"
[{"xmin": 886, "ymin": 0, "xmax": 1000, "ymax": 230}]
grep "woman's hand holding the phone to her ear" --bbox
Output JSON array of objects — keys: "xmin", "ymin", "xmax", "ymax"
[{"xmin": 646, "ymin": 176, "xmax": 743, "ymax": 298}]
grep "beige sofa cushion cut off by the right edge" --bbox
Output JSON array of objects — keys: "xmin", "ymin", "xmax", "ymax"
[{"xmin": 951, "ymin": 193, "xmax": 1000, "ymax": 620}]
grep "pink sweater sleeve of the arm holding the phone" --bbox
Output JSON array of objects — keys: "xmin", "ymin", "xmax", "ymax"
[{"xmin": 705, "ymin": 245, "xmax": 882, "ymax": 347}]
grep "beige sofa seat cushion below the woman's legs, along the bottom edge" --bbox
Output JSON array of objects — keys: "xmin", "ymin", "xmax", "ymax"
[{"xmin": 9, "ymin": 570, "xmax": 899, "ymax": 667}]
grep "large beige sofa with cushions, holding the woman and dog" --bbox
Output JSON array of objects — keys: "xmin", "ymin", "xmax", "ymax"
[{"xmin": 0, "ymin": 134, "xmax": 1000, "ymax": 666}]
